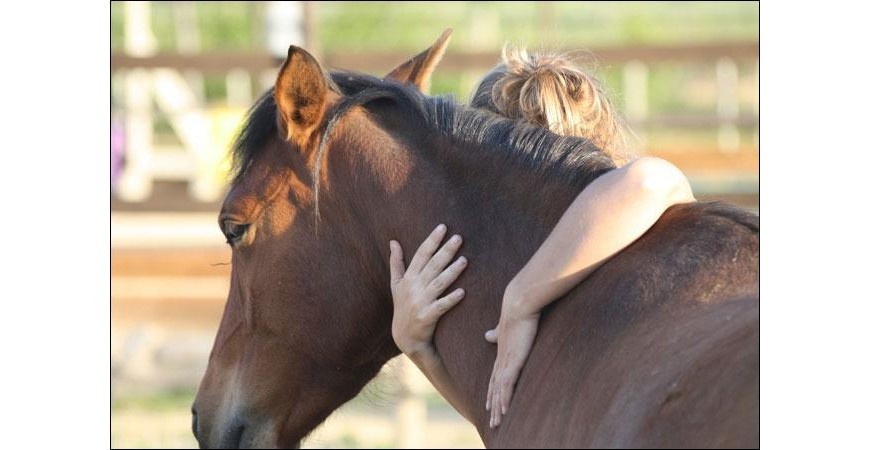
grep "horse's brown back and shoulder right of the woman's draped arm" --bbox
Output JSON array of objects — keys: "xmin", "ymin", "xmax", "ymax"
[{"xmin": 489, "ymin": 203, "xmax": 759, "ymax": 448}]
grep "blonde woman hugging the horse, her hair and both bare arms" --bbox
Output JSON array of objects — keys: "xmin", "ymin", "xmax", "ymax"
[{"xmin": 390, "ymin": 48, "xmax": 695, "ymax": 427}]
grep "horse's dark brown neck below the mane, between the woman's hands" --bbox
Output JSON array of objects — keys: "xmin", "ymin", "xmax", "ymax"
[{"xmin": 372, "ymin": 134, "xmax": 608, "ymax": 435}]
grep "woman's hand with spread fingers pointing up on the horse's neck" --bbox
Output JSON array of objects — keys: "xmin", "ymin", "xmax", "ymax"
[{"xmin": 390, "ymin": 225, "xmax": 467, "ymax": 357}]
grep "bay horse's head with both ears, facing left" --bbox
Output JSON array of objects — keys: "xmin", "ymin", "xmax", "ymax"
[{"xmin": 193, "ymin": 30, "xmax": 450, "ymax": 447}]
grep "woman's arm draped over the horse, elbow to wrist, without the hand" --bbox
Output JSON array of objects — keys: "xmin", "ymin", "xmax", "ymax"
[{"xmin": 505, "ymin": 158, "xmax": 694, "ymax": 313}]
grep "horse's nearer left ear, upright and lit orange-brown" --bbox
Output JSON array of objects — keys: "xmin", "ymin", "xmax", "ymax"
[{"xmin": 274, "ymin": 45, "xmax": 328, "ymax": 139}]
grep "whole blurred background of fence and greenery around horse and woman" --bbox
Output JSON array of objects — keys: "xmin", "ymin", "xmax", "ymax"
[{"xmin": 111, "ymin": 2, "xmax": 759, "ymax": 448}]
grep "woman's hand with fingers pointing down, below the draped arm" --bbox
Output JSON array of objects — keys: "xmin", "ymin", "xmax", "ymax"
[{"xmin": 485, "ymin": 288, "xmax": 540, "ymax": 428}]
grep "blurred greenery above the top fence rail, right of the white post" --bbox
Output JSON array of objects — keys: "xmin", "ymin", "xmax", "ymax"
[{"xmin": 314, "ymin": 2, "xmax": 758, "ymax": 52}]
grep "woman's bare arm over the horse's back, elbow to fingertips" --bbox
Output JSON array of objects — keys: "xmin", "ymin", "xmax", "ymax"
[{"xmin": 486, "ymin": 158, "xmax": 695, "ymax": 426}]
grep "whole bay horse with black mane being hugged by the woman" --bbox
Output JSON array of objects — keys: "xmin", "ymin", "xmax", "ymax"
[{"xmin": 193, "ymin": 34, "xmax": 759, "ymax": 448}]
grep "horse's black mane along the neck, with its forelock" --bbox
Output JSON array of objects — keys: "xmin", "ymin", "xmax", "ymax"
[{"xmin": 232, "ymin": 68, "xmax": 616, "ymax": 189}]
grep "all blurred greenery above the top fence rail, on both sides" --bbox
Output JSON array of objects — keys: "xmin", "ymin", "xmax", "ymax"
[{"xmin": 111, "ymin": 2, "xmax": 759, "ymax": 52}]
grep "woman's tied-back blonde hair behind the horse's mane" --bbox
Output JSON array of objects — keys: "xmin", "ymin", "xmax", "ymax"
[{"xmin": 471, "ymin": 45, "xmax": 630, "ymax": 162}]
